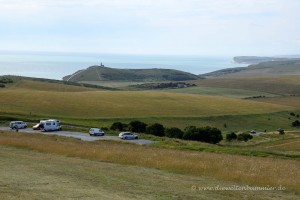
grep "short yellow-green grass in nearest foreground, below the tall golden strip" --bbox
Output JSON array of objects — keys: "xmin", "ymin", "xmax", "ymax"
[{"xmin": 0, "ymin": 146, "xmax": 297, "ymax": 200}]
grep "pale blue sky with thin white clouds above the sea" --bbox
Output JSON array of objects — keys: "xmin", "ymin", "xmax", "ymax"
[{"xmin": 0, "ymin": 0, "xmax": 300, "ymax": 56}]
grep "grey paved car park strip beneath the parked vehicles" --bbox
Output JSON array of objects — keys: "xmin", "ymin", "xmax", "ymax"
[{"xmin": 0, "ymin": 126, "xmax": 154, "ymax": 145}]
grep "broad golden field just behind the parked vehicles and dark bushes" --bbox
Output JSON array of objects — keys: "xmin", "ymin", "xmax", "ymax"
[{"xmin": 0, "ymin": 89, "xmax": 292, "ymax": 118}]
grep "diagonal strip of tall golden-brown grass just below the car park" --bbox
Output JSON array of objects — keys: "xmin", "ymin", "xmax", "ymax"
[{"xmin": 0, "ymin": 131, "xmax": 300, "ymax": 191}]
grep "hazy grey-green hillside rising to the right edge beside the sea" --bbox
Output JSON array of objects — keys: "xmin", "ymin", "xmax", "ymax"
[{"xmin": 201, "ymin": 59, "xmax": 300, "ymax": 78}]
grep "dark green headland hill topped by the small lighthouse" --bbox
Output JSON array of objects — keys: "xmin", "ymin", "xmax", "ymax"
[{"xmin": 63, "ymin": 65, "xmax": 199, "ymax": 82}]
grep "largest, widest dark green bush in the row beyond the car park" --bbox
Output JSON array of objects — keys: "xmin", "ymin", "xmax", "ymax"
[{"xmin": 182, "ymin": 126, "xmax": 223, "ymax": 144}]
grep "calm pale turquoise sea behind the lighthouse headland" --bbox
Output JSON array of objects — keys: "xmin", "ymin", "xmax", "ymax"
[{"xmin": 0, "ymin": 51, "xmax": 247, "ymax": 80}]
